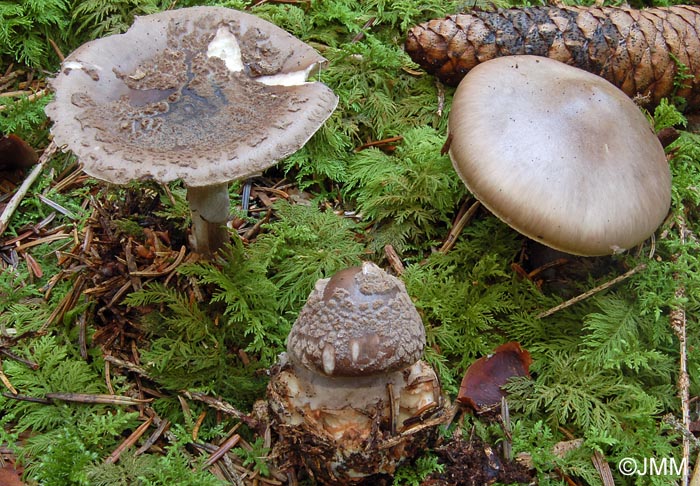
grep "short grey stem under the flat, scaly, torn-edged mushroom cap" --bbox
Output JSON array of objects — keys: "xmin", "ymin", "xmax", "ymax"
[{"xmin": 187, "ymin": 183, "xmax": 230, "ymax": 257}]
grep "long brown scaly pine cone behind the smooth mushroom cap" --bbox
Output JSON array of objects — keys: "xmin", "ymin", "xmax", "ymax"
[{"xmin": 406, "ymin": 6, "xmax": 700, "ymax": 108}]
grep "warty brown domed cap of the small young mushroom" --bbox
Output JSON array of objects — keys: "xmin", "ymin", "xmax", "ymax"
[{"xmin": 287, "ymin": 262, "xmax": 425, "ymax": 376}]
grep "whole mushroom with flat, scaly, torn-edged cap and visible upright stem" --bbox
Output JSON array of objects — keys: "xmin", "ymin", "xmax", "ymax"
[{"xmin": 46, "ymin": 7, "xmax": 338, "ymax": 255}]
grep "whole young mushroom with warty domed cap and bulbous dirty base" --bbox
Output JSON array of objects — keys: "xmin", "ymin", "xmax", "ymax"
[{"xmin": 268, "ymin": 262, "xmax": 444, "ymax": 483}]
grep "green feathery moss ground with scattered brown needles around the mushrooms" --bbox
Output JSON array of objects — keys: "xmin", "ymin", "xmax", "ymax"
[{"xmin": 0, "ymin": 0, "xmax": 700, "ymax": 485}]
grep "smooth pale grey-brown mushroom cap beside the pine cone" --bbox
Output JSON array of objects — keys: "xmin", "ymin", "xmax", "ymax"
[{"xmin": 449, "ymin": 56, "xmax": 671, "ymax": 256}]
